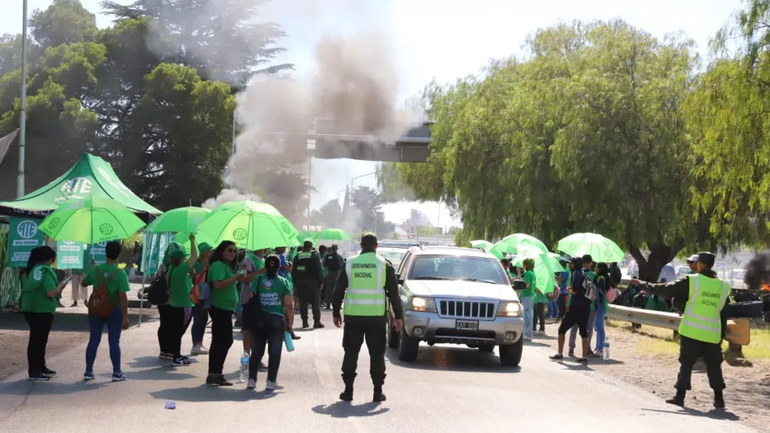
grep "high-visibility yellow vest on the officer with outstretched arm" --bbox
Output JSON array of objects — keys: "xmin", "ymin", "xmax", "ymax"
[{"xmin": 679, "ymin": 274, "xmax": 730, "ymax": 344}]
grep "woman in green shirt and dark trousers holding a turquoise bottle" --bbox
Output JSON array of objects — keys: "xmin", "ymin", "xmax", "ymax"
[{"xmin": 246, "ymin": 256, "xmax": 294, "ymax": 391}]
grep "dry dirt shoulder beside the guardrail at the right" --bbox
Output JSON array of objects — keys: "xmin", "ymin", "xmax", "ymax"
[{"xmin": 532, "ymin": 323, "xmax": 770, "ymax": 432}]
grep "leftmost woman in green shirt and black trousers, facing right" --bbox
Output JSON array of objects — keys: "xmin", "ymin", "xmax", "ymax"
[{"xmin": 21, "ymin": 246, "xmax": 64, "ymax": 382}]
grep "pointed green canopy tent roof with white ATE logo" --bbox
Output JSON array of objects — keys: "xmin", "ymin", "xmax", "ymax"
[{"xmin": 0, "ymin": 153, "xmax": 161, "ymax": 222}]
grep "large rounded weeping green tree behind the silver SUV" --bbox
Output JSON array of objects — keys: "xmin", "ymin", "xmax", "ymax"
[{"xmin": 390, "ymin": 20, "xmax": 713, "ymax": 279}]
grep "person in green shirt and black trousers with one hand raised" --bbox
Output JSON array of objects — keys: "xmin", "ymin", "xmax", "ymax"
[{"xmin": 167, "ymin": 235, "xmax": 198, "ymax": 365}]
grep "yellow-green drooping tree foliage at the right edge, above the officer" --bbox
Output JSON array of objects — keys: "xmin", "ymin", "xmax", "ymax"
[{"xmin": 687, "ymin": 0, "xmax": 770, "ymax": 246}]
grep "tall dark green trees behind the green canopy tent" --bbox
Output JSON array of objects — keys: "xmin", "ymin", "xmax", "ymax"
[{"xmin": 0, "ymin": 0, "xmax": 290, "ymax": 209}]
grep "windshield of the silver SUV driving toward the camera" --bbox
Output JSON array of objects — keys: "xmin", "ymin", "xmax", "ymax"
[{"xmin": 410, "ymin": 256, "xmax": 510, "ymax": 285}]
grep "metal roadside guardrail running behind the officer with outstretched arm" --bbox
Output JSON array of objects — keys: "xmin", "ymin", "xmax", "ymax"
[{"xmin": 607, "ymin": 305, "xmax": 751, "ymax": 352}]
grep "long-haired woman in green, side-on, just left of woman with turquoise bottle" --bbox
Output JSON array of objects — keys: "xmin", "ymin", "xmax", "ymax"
[{"xmin": 206, "ymin": 241, "xmax": 248, "ymax": 386}]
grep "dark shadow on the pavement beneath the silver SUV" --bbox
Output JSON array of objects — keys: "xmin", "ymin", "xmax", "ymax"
[{"xmin": 385, "ymin": 345, "xmax": 521, "ymax": 373}]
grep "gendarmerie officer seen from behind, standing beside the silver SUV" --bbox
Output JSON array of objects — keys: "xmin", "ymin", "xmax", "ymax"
[{"xmin": 334, "ymin": 233, "xmax": 404, "ymax": 402}]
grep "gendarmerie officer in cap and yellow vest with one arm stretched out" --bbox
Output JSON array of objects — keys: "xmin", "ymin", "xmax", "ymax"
[{"xmin": 631, "ymin": 253, "xmax": 730, "ymax": 409}]
